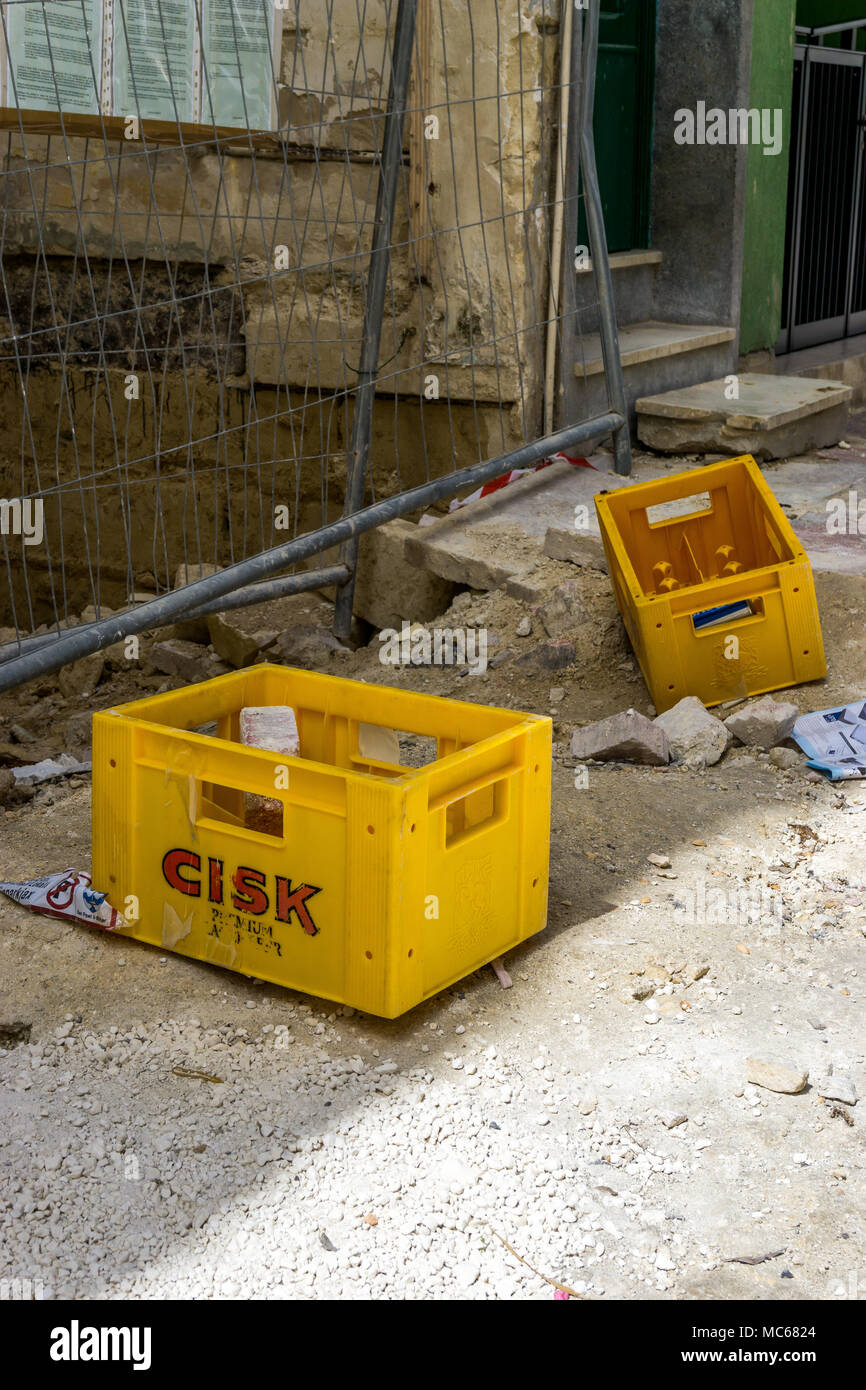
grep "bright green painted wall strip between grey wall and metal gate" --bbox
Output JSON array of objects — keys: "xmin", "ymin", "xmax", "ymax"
[{"xmin": 740, "ymin": 0, "xmax": 800, "ymax": 353}]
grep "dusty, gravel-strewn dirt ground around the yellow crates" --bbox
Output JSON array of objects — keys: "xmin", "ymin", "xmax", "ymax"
[{"xmin": 0, "ymin": 475, "xmax": 866, "ymax": 1300}]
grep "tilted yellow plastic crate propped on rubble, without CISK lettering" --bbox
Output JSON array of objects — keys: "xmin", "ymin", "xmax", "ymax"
[{"xmin": 595, "ymin": 455, "xmax": 827, "ymax": 713}]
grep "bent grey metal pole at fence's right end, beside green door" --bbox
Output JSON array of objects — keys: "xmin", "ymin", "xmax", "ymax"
[{"xmin": 575, "ymin": 3, "xmax": 631, "ymax": 474}]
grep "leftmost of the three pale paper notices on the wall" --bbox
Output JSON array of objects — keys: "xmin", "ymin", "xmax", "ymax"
[{"xmin": 3, "ymin": 0, "xmax": 103, "ymax": 114}]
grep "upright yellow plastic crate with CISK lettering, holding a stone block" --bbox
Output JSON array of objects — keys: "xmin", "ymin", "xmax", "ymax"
[{"xmin": 93, "ymin": 666, "xmax": 552, "ymax": 1017}]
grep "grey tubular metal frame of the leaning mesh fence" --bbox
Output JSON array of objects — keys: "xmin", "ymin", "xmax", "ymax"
[{"xmin": 0, "ymin": 0, "xmax": 631, "ymax": 691}]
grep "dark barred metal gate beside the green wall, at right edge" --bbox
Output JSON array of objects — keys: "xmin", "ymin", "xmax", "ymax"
[{"xmin": 777, "ymin": 44, "xmax": 866, "ymax": 353}]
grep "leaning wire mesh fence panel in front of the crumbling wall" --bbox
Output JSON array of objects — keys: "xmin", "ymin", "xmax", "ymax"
[{"xmin": 0, "ymin": 0, "xmax": 624, "ymax": 687}]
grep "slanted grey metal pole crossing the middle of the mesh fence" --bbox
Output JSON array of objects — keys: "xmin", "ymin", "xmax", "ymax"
[{"xmin": 334, "ymin": 0, "xmax": 418, "ymax": 641}]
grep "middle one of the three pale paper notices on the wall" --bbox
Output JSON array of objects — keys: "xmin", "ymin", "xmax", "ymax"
[{"xmin": 114, "ymin": 0, "xmax": 197, "ymax": 121}]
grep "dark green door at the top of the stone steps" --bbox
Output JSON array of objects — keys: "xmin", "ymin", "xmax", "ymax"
[{"xmin": 581, "ymin": 0, "xmax": 656, "ymax": 252}]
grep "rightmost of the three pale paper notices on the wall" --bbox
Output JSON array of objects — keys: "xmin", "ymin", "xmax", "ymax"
[{"xmin": 202, "ymin": 0, "xmax": 282, "ymax": 131}]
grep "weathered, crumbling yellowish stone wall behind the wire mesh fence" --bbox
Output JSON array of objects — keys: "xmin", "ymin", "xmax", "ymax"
[{"xmin": 0, "ymin": 0, "xmax": 557, "ymax": 626}]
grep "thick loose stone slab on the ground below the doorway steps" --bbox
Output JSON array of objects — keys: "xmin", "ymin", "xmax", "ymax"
[{"xmin": 635, "ymin": 373, "xmax": 852, "ymax": 459}]
